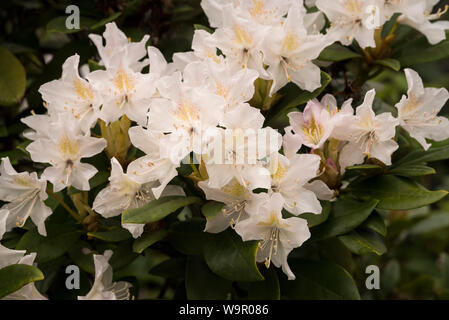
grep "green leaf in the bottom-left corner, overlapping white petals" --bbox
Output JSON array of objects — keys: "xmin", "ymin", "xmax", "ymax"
[{"xmin": 0, "ymin": 264, "xmax": 44, "ymax": 299}]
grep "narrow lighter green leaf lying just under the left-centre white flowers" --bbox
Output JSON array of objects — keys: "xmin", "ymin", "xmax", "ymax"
[{"xmin": 122, "ymin": 196, "xmax": 201, "ymax": 224}]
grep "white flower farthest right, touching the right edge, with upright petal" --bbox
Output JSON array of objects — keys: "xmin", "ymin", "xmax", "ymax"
[{"xmin": 396, "ymin": 69, "xmax": 449, "ymax": 150}]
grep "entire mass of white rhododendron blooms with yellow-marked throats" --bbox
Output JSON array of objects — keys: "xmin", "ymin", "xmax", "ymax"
[{"xmin": 0, "ymin": 0, "xmax": 449, "ymax": 299}]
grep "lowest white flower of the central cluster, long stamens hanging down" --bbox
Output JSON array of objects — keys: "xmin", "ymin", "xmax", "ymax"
[{"xmin": 235, "ymin": 193, "xmax": 310, "ymax": 280}]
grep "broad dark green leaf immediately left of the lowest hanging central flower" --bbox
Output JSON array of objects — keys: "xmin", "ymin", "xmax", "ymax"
[{"xmin": 204, "ymin": 230, "xmax": 264, "ymax": 281}]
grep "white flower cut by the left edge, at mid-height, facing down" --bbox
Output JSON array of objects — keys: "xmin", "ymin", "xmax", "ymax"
[{"xmin": 0, "ymin": 158, "xmax": 52, "ymax": 236}]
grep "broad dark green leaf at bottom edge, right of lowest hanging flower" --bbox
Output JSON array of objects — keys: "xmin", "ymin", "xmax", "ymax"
[{"xmin": 281, "ymin": 259, "xmax": 360, "ymax": 300}]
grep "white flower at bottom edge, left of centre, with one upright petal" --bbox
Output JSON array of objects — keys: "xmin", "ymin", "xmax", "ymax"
[{"xmin": 78, "ymin": 250, "xmax": 131, "ymax": 300}]
